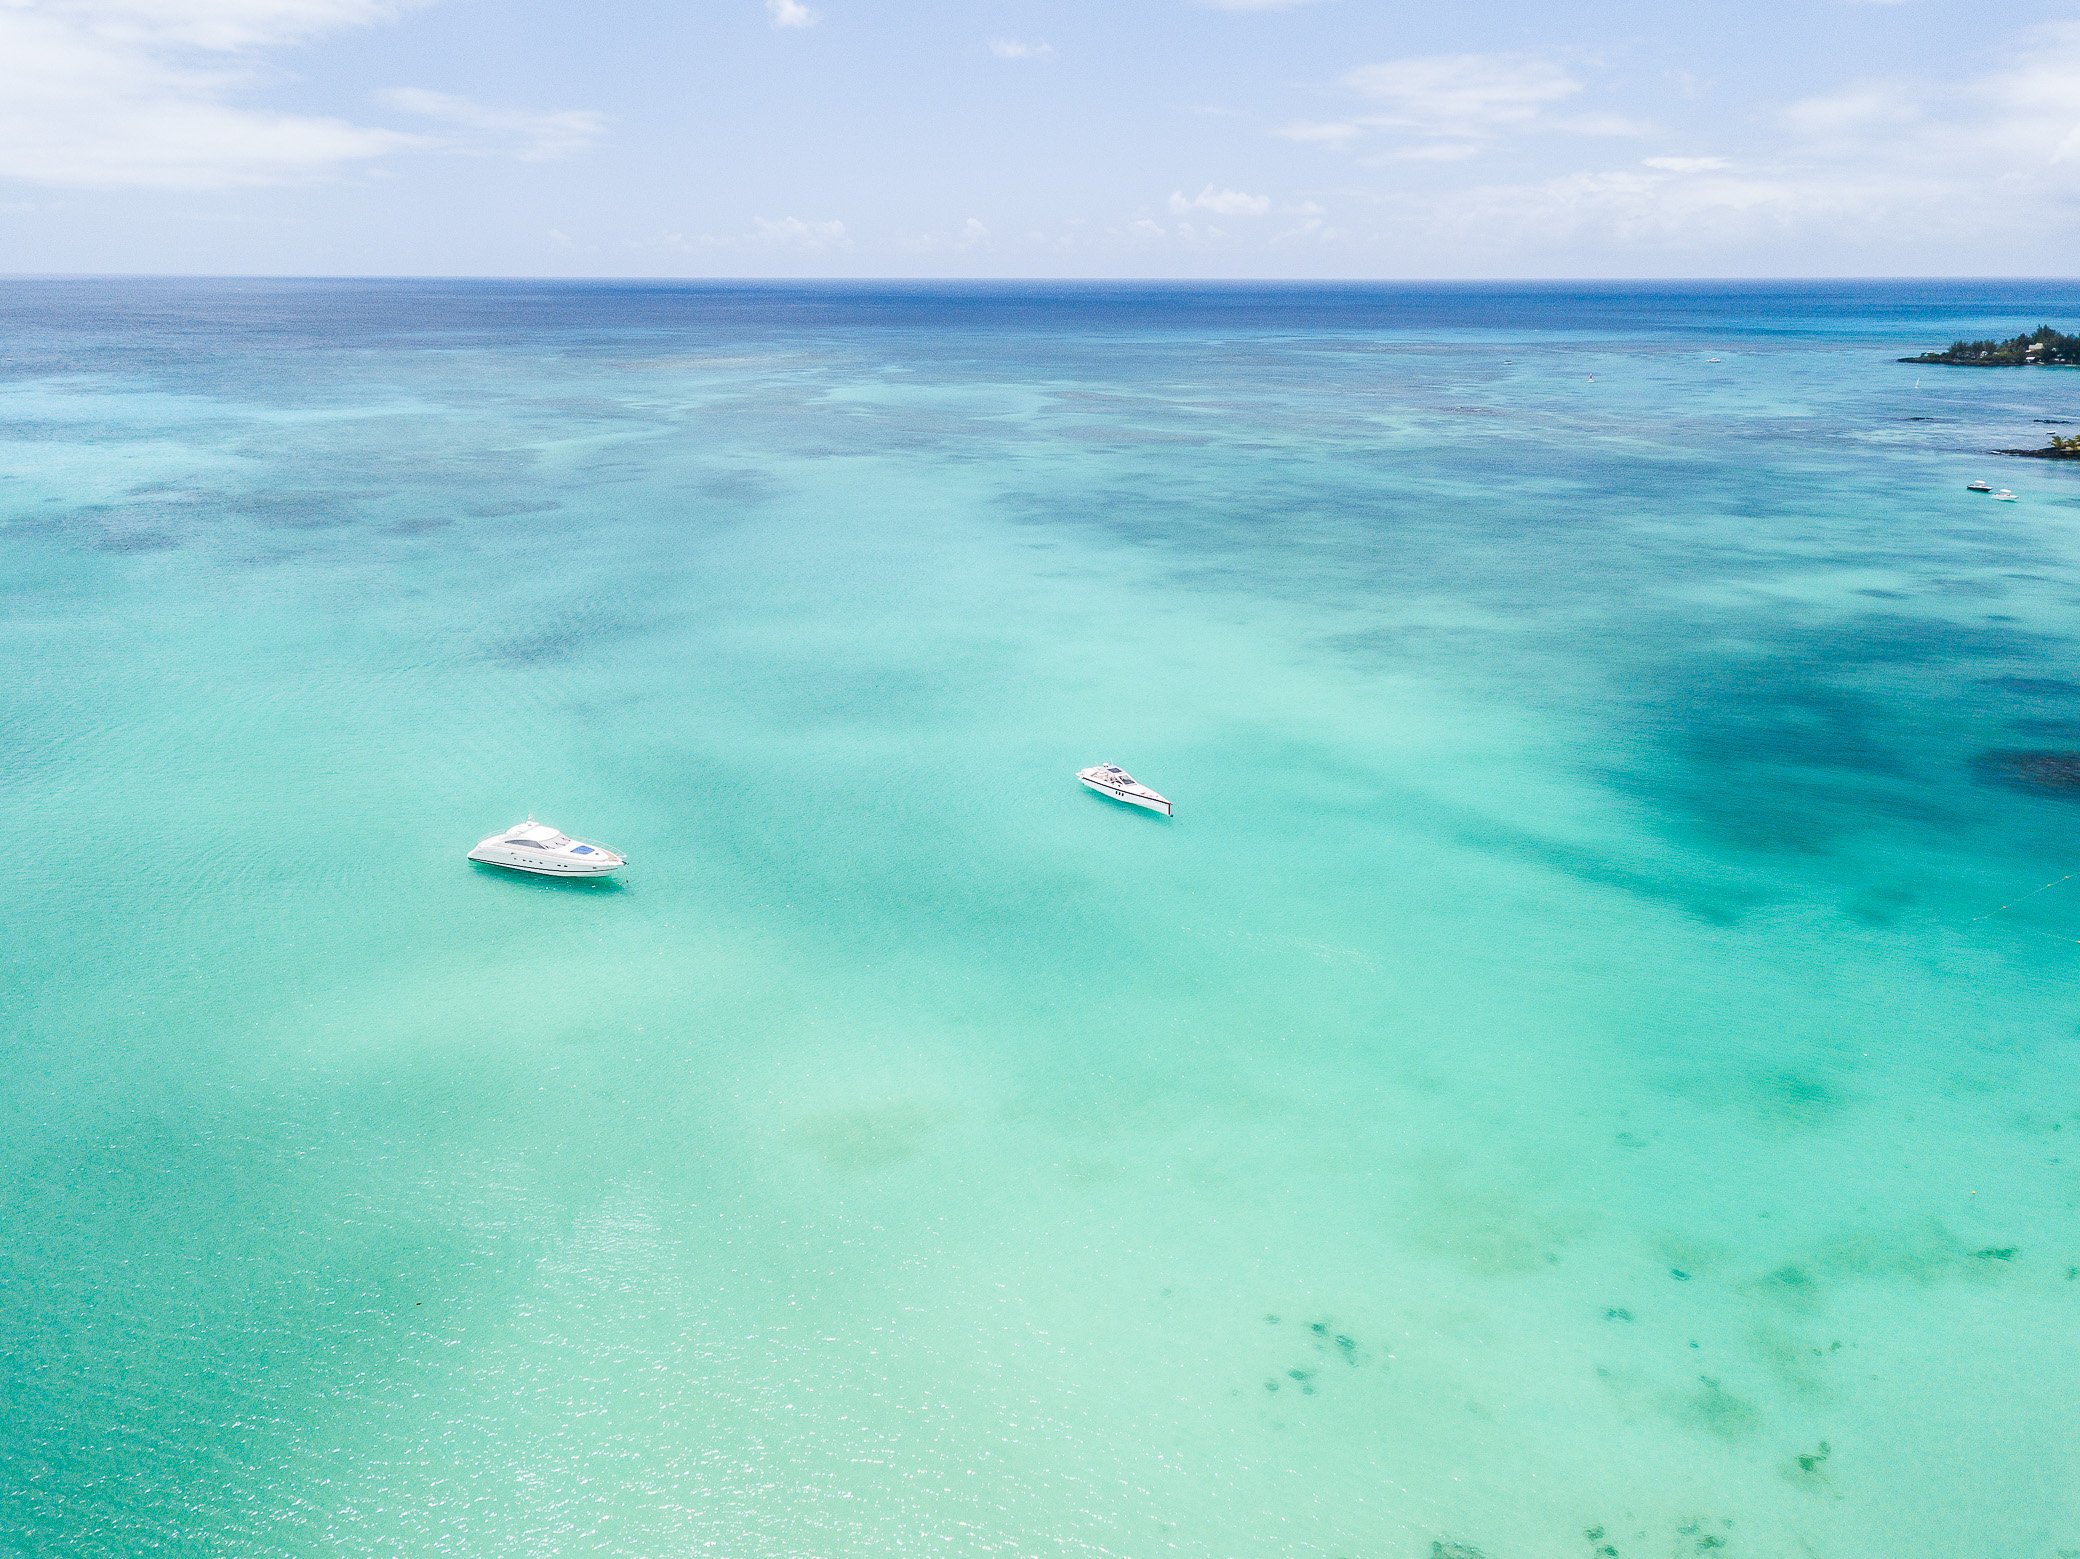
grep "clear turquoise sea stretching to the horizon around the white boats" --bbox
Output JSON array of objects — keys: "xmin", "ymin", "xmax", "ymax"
[{"xmin": 0, "ymin": 283, "xmax": 2080, "ymax": 1559}]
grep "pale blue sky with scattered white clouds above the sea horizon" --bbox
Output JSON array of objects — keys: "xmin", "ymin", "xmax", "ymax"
[{"xmin": 0, "ymin": 0, "xmax": 2080, "ymax": 279}]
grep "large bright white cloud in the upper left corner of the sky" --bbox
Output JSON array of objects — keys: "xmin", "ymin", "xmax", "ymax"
[{"xmin": 0, "ymin": 0, "xmax": 424, "ymax": 189}]
